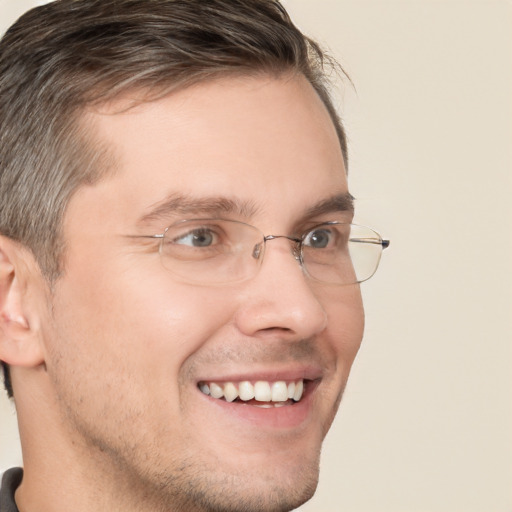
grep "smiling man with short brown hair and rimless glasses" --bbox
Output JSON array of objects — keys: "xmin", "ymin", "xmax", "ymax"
[{"xmin": 0, "ymin": 0, "xmax": 387, "ymax": 512}]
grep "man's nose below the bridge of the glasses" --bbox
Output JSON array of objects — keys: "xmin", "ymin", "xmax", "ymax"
[{"xmin": 235, "ymin": 237, "xmax": 327, "ymax": 339}]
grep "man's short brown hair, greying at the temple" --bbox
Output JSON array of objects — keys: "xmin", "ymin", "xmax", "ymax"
[{"xmin": 0, "ymin": 0, "xmax": 347, "ymax": 393}]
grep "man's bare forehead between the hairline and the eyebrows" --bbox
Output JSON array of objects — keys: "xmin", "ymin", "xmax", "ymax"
[{"xmin": 70, "ymin": 72, "xmax": 347, "ymax": 232}]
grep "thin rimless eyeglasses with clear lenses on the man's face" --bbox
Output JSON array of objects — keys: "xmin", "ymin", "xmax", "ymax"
[{"xmin": 136, "ymin": 219, "xmax": 389, "ymax": 285}]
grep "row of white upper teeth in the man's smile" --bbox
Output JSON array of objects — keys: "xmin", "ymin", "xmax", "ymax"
[{"xmin": 199, "ymin": 379, "xmax": 304, "ymax": 402}]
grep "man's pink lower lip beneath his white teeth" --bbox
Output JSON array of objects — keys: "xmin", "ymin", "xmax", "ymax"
[{"xmin": 199, "ymin": 381, "xmax": 318, "ymax": 430}]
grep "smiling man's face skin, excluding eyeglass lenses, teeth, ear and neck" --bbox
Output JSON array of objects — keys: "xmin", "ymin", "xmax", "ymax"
[{"xmin": 43, "ymin": 76, "xmax": 363, "ymax": 511}]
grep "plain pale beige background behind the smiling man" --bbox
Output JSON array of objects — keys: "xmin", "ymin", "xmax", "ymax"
[{"xmin": 0, "ymin": 0, "xmax": 512, "ymax": 512}]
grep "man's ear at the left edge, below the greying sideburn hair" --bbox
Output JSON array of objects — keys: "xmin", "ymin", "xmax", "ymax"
[{"xmin": 0, "ymin": 236, "xmax": 44, "ymax": 367}]
